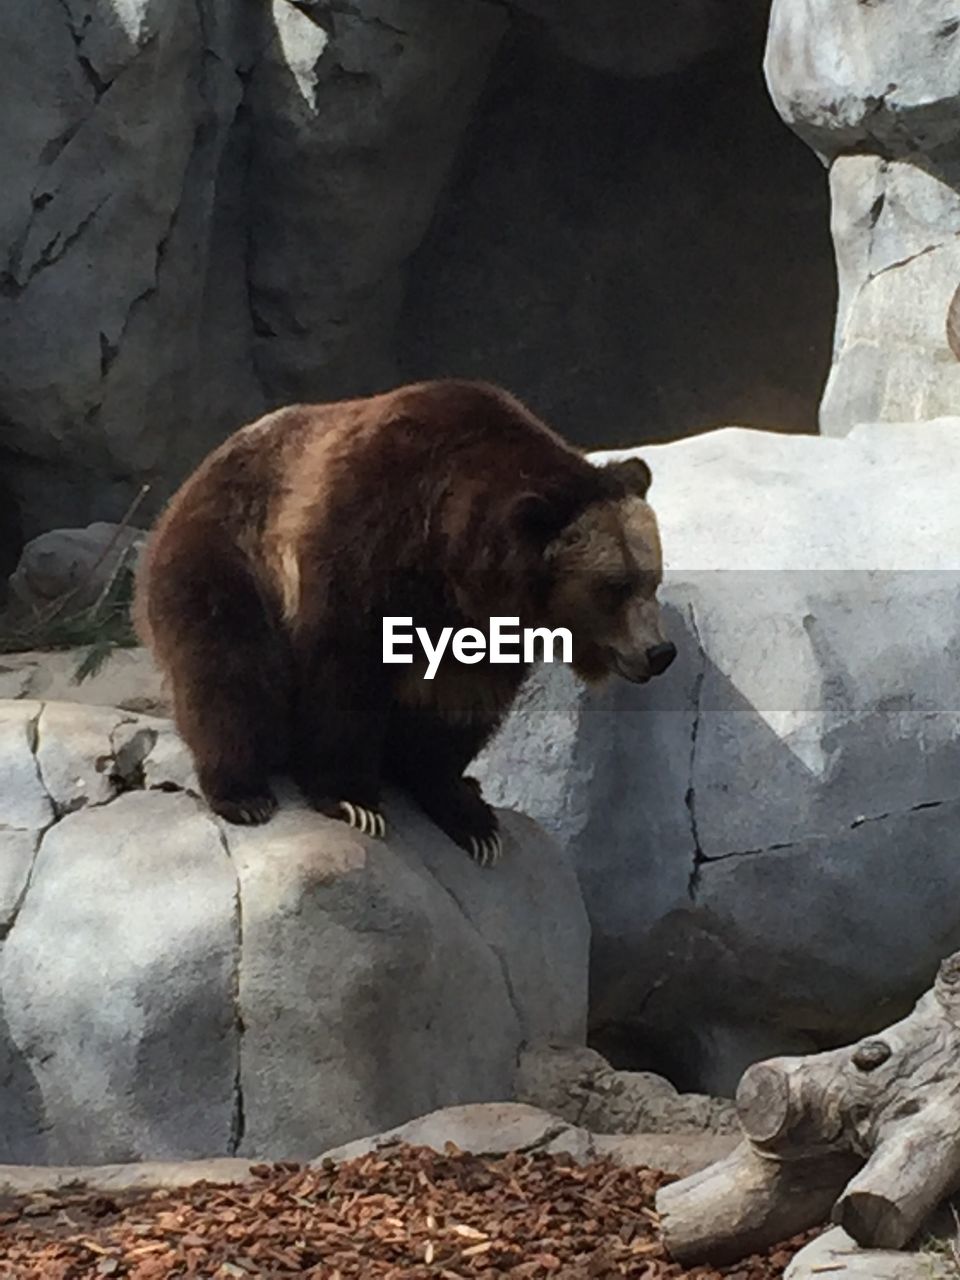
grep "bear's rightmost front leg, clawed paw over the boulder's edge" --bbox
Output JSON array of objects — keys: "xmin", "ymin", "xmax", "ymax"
[{"xmin": 384, "ymin": 705, "xmax": 502, "ymax": 867}]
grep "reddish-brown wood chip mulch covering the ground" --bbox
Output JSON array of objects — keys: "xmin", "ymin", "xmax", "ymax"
[{"xmin": 0, "ymin": 1146, "xmax": 805, "ymax": 1280}]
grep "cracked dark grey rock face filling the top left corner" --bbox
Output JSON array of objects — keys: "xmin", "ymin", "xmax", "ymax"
[{"xmin": 0, "ymin": 0, "xmax": 263, "ymax": 536}]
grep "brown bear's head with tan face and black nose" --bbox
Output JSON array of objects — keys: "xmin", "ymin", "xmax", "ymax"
[{"xmin": 543, "ymin": 458, "xmax": 677, "ymax": 684}]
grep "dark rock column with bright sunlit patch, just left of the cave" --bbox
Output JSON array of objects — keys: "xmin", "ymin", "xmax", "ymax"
[{"xmin": 246, "ymin": 0, "xmax": 507, "ymax": 403}]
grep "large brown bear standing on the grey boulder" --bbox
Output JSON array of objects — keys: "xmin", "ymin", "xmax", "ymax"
[{"xmin": 136, "ymin": 380, "xmax": 676, "ymax": 864}]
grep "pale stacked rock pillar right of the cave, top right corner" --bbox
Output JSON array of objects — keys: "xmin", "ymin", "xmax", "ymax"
[{"xmin": 765, "ymin": 0, "xmax": 960, "ymax": 435}]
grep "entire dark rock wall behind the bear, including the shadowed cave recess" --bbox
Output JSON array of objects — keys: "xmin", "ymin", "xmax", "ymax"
[{"xmin": 0, "ymin": 0, "xmax": 835, "ymax": 561}]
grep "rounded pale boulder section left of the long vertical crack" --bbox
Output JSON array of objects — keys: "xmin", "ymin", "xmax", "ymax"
[{"xmin": 0, "ymin": 792, "xmax": 241, "ymax": 1162}]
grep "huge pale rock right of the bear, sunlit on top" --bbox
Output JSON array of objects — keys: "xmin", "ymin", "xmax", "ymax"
[{"xmin": 481, "ymin": 419, "xmax": 960, "ymax": 1093}]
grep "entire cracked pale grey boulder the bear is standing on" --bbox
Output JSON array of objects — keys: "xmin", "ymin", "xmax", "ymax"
[{"xmin": 0, "ymin": 700, "xmax": 589, "ymax": 1164}]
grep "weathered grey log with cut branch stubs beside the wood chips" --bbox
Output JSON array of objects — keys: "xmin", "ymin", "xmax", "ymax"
[{"xmin": 658, "ymin": 952, "xmax": 960, "ymax": 1262}]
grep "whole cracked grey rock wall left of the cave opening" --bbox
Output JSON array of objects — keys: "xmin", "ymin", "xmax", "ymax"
[{"xmin": 0, "ymin": 0, "xmax": 507, "ymax": 538}]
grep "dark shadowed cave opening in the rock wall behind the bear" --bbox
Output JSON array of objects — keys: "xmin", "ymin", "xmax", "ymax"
[{"xmin": 399, "ymin": 24, "xmax": 836, "ymax": 447}]
